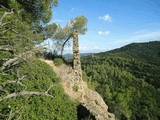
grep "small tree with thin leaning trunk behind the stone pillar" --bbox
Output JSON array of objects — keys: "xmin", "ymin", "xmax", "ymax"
[{"xmin": 54, "ymin": 16, "xmax": 87, "ymax": 56}]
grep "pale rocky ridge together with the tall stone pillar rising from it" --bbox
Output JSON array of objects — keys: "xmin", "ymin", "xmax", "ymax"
[{"xmin": 41, "ymin": 30, "xmax": 115, "ymax": 120}]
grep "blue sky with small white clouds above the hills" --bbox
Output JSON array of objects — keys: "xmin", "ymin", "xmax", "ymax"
[{"xmin": 50, "ymin": 0, "xmax": 160, "ymax": 53}]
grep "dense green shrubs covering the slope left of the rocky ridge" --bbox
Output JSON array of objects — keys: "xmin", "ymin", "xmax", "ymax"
[{"xmin": 0, "ymin": 60, "xmax": 77, "ymax": 120}]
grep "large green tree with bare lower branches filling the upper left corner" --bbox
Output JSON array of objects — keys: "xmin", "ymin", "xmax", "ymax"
[{"xmin": 0, "ymin": 0, "xmax": 58, "ymax": 70}]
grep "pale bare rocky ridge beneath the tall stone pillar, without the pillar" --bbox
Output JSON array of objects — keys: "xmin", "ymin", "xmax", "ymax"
[{"xmin": 44, "ymin": 60, "xmax": 115, "ymax": 120}]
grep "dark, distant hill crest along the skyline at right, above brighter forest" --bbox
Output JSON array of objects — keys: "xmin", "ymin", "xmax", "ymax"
[{"xmin": 98, "ymin": 41, "xmax": 160, "ymax": 66}]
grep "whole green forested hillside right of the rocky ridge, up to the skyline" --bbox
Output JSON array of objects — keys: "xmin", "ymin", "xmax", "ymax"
[{"xmin": 82, "ymin": 41, "xmax": 160, "ymax": 120}]
